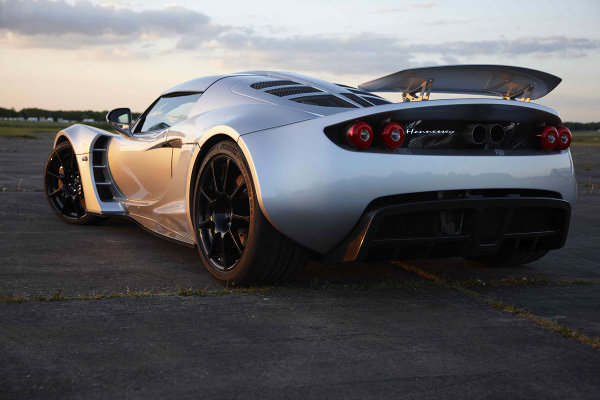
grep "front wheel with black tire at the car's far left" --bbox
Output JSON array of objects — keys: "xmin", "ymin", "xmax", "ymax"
[{"xmin": 44, "ymin": 142, "xmax": 102, "ymax": 225}]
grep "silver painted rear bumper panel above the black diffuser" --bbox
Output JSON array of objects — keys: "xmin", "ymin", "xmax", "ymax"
[{"xmin": 238, "ymin": 117, "xmax": 577, "ymax": 255}]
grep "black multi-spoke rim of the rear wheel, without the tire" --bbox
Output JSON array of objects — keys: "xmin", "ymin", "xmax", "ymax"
[{"xmin": 196, "ymin": 154, "xmax": 250, "ymax": 271}]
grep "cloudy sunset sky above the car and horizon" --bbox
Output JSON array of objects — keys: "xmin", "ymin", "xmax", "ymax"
[{"xmin": 0, "ymin": 0, "xmax": 600, "ymax": 122}]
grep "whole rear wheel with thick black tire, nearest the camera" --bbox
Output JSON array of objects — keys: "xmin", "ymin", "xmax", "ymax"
[{"xmin": 192, "ymin": 140, "xmax": 309, "ymax": 286}]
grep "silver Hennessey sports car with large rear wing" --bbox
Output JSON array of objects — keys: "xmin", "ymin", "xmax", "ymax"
[{"xmin": 44, "ymin": 65, "xmax": 577, "ymax": 285}]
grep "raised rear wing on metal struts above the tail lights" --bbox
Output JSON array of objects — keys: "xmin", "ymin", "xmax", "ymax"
[{"xmin": 358, "ymin": 65, "xmax": 562, "ymax": 101}]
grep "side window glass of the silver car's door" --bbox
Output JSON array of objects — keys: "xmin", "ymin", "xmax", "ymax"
[{"xmin": 134, "ymin": 93, "xmax": 202, "ymax": 133}]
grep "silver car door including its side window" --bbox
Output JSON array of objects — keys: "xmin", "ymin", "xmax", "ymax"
[{"xmin": 108, "ymin": 93, "xmax": 201, "ymax": 204}]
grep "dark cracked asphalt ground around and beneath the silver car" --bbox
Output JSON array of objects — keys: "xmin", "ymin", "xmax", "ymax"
[{"xmin": 0, "ymin": 134, "xmax": 600, "ymax": 399}]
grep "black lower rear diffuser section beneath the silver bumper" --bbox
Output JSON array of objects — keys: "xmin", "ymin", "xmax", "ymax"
[{"xmin": 322, "ymin": 190, "xmax": 571, "ymax": 262}]
